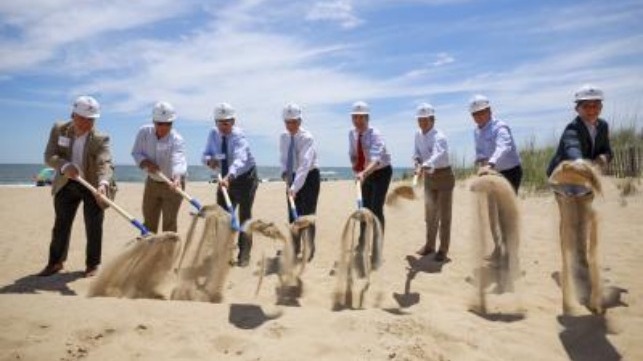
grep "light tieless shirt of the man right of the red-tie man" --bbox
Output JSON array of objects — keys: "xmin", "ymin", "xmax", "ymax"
[{"xmin": 413, "ymin": 128, "xmax": 450, "ymax": 169}]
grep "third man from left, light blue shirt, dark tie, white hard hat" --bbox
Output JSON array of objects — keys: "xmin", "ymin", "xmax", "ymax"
[{"xmin": 203, "ymin": 103, "xmax": 259, "ymax": 267}]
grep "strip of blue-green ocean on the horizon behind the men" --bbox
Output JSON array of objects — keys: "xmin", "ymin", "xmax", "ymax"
[{"xmin": 0, "ymin": 164, "xmax": 412, "ymax": 185}]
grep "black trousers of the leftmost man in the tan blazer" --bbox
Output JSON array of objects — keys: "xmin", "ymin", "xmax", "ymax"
[{"xmin": 48, "ymin": 180, "xmax": 105, "ymax": 267}]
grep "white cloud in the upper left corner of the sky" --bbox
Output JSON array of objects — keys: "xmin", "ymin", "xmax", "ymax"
[{"xmin": 0, "ymin": 0, "xmax": 197, "ymax": 72}]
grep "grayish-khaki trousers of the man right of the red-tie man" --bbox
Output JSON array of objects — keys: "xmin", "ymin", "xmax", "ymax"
[{"xmin": 424, "ymin": 167, "xmax": 455, "ymax": 254}]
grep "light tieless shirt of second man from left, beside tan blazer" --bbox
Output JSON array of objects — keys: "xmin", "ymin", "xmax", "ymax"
[{"xmin": 132, "ymin": 124, "xmax": 188, "ymax": 182}]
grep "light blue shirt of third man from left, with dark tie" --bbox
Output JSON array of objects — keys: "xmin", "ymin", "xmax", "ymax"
[{"xmin": 202, "ymin": 126, "xmax": 256, "ymax": 178}]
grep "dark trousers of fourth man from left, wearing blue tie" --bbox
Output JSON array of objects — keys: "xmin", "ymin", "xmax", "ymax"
[{"xmin": 286, "ymin": 168, "xmax": 321, "ymax": 254}]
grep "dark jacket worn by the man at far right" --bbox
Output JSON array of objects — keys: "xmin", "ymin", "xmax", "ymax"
[{"xmin": 547, "ymin": 117, "xmax": 612, "ymax": 177}]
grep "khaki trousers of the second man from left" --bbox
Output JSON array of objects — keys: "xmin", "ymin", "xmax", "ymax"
[{"xmin": 143, "ymin": 177, "xmax": 185, "ymax": 233}]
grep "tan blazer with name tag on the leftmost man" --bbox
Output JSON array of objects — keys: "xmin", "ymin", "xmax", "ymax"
[{"xmin": 45, "ymin": 121, "xmax": 114, "ymax": 195}]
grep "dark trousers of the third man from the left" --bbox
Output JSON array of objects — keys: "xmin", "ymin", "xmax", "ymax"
[{"xmin": 217, "ymin": 167, "xmax": 259, "ymax": 260}]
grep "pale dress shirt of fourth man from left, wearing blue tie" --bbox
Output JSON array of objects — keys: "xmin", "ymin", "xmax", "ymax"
[{"xmin": 279, "ymin": 127, "xmax": 319, "ymax": 193}]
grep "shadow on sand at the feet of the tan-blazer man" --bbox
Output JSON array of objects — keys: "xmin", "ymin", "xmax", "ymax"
[{"xmin": 0, "ymin": 271, "xmax": 83, "ymax": 296}]
